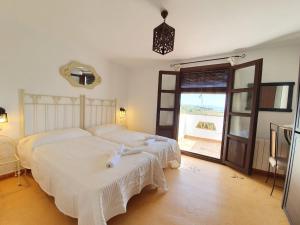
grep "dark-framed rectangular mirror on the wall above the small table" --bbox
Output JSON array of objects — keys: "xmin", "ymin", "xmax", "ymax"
[{"xmin": 259, "ymin": 82, "xmax": 295, "ymax": 112}]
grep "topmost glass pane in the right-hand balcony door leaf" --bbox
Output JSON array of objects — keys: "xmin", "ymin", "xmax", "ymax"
[{"xmin": 233, "ymin": 66, "xmax": 255, "ymax": 89}]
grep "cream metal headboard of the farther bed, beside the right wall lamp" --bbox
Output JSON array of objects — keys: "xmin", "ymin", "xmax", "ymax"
[{"xmin": 84, "ymin": 98, "xmax": 117, "ymax": 128}]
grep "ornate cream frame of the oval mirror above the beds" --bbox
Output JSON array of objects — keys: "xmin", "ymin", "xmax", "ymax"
[{"xmin": 59, "ymin": 60, "xmax": 102, "ymax": 89}]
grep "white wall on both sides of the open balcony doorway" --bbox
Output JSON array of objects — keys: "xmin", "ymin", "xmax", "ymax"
[{"xmin": 128, "ymin": 45, "xmax": 300, "ymax": 138}]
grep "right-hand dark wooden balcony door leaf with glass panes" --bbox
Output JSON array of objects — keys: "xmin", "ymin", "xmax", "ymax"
[{"xmin": 223, "ymin": 59, "xmax": 263, "ymax": 174}]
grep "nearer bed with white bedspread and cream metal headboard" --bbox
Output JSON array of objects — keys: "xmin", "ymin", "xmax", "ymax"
[{"xmin": 18, "ymin": 91, "xmax": 167, "ymax": 225}]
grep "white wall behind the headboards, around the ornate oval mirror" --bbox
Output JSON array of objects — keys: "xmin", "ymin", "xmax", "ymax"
[{"xmin": 0, "ymin": 17, "xmax": 128, "ymax": 138}]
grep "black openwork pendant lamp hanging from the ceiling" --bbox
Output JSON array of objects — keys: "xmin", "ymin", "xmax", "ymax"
[{"xmin": 152, "ymin": 10, "xmax": 175, "ymax": 55}]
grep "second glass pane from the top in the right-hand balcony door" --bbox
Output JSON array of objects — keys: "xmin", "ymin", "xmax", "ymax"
[{"xmin": 232, "ymin": 92, "xmax": 252, "ymax": 113}]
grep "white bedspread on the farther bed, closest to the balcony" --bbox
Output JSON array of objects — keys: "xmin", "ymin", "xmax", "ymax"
[{"xmin": 88, "ymin": 125, "xmax": 181, "ymax": 168}]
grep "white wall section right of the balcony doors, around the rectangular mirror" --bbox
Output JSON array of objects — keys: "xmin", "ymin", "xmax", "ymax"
[{"xmin": 246, "ymin": 46, "xmax": 300, "ymax": 138}]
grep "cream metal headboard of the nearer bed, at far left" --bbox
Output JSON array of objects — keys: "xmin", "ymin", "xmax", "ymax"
[{"xmin": 19, "ymin": 90, "xmax": 84, "ymax": 137}]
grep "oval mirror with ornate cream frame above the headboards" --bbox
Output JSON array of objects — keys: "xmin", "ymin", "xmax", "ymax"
[{"xmin": 59, "ymin": 61, "xmax": 101, "ymax": 89}]
